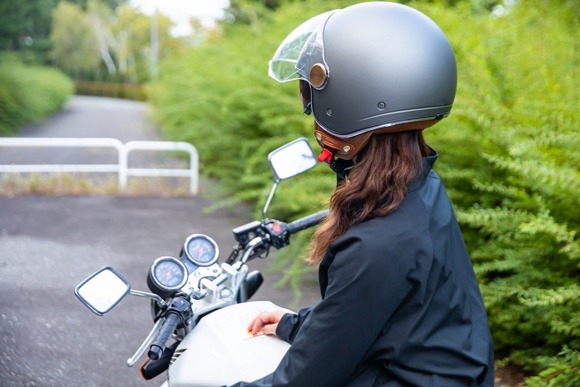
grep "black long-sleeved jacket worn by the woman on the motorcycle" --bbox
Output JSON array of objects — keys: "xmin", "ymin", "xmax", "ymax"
[{"xmin": 231, "ymin": 156, "xmax": 493, "ymax": 387}]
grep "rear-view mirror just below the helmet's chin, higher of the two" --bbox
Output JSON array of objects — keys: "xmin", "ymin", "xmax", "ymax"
[{"xmin": 268, "ymin": 137, "xmax": 317, "ymax": 182}]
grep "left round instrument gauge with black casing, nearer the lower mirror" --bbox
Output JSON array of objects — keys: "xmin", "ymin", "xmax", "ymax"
[{"xmin": 147, "ymin": 256, "xmax": 188, "ymax": 296}]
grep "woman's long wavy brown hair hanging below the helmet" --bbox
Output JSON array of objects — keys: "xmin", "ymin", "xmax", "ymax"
[{"xmin": 307, "ymin": 130, "xmax": 429, "ymax": 264}]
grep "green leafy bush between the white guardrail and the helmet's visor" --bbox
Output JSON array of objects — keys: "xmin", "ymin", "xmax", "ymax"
[{"xmin": 148, "ymin": 0, "xmax": 348, "ymax": 216}]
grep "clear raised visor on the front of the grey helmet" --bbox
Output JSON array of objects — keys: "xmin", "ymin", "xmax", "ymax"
[{"xmin": 268, "ymin": 10, "xmax": 336, "ymax": 87}]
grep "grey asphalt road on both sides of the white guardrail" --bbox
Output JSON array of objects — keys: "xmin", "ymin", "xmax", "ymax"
[{"xmin": 0, "ymin": 97, "xmax": 318, "ymax": 386}]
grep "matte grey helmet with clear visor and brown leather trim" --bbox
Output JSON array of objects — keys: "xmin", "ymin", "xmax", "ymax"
[{"xmin": 269, "ymin": 2, "xmax": 457, "ymax": 158}]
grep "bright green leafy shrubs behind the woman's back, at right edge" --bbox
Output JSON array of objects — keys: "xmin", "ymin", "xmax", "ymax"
[{"xmin": 416, "ymin": 1, "xmax": 580, "ymax": 386}]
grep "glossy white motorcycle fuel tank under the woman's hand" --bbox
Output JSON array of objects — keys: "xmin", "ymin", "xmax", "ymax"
[{"xmin": 168, "ymin": 301, "xmax": 291, "ymax": 387}]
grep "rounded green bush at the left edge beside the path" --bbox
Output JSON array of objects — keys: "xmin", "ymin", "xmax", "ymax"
[{"xmin": 0, "ymin": 55, "xmax": 74, "ymax": 136}]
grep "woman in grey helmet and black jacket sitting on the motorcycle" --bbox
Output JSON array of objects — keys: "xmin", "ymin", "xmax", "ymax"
[{"xmin": 232, "ymin": 2, "xmax": 493, "ymax": 387}]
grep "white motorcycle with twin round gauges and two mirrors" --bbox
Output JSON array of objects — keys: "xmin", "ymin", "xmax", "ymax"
[{"xmin": 75, "ymin": 138, "xmax": 328, "ymax": 387}]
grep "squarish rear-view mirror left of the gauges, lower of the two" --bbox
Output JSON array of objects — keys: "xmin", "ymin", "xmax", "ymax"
[{"xmin": 75, "ymin": 266, "xmax": 131, "ymax": 316}]
